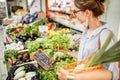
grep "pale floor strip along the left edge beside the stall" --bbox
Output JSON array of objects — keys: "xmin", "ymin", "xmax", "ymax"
[{"xmin": 0, "ymin": 26, "xmax": 7, "ymax": 80}]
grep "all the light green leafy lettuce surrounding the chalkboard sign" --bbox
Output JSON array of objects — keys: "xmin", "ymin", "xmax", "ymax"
[{"xmin": 26, "ymin": 34, "xmax": 79, "ymax": 80}]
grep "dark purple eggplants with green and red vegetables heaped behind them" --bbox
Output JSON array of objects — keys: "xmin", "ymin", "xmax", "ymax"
[{"xmin": 7, "ymin": 18, "xmax": 47, "ymax": 42}]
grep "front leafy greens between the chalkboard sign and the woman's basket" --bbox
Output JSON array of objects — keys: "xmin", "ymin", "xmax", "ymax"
[{"xmin": 39, "ymin": 52, "xmax": 76, "ymax": 80}]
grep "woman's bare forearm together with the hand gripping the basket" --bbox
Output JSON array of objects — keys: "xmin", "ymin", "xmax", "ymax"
[{"xmin": 57, "ymin": 69, "xmax": 112, "ymax": 80}]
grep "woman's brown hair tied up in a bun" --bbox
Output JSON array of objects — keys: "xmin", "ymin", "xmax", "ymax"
[{"xmin": 74, "ymin": 0, "xmax": 105, "ymax": 17}]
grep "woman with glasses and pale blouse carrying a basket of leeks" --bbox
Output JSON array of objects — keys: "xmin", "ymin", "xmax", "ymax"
[{"xmin": 57, "ymin": 0, "xmax": 119, "ymax": 80}]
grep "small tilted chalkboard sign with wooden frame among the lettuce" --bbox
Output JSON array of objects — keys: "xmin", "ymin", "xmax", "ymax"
[{"xmin": 33, "ymin": 49, "xmax": 53, "ymax": 70}]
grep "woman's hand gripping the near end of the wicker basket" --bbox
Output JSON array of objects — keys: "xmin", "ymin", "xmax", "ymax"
[{"xmin": 57, "ymin": 68, "xmax": 69, "ymax": 80}]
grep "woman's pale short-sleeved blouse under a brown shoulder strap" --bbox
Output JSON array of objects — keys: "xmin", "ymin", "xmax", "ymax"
[{"xmin": 78, "ymin": 23, "xmax": 119, "ymax": 80}]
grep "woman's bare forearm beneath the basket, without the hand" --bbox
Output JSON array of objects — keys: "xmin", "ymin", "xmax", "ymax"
[{"xmin": 74, "ymin": 69, "xmax": 112, "ymax": 80}]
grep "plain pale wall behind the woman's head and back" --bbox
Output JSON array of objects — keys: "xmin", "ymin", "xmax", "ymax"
[{"xmin": 106, "ymin": 0, "xmax": 120, "ymax": 36}]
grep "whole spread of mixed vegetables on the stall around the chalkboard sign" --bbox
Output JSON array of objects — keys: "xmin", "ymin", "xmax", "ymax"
[{"xmin": 4, "ymin": 19, "xmax": 80, "ymax": 80}]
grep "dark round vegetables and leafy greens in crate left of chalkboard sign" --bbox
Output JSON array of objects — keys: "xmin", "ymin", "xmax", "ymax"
[{"xmin": 4, "ymin": 50, "xmax": 31, "ymax": 69}]
